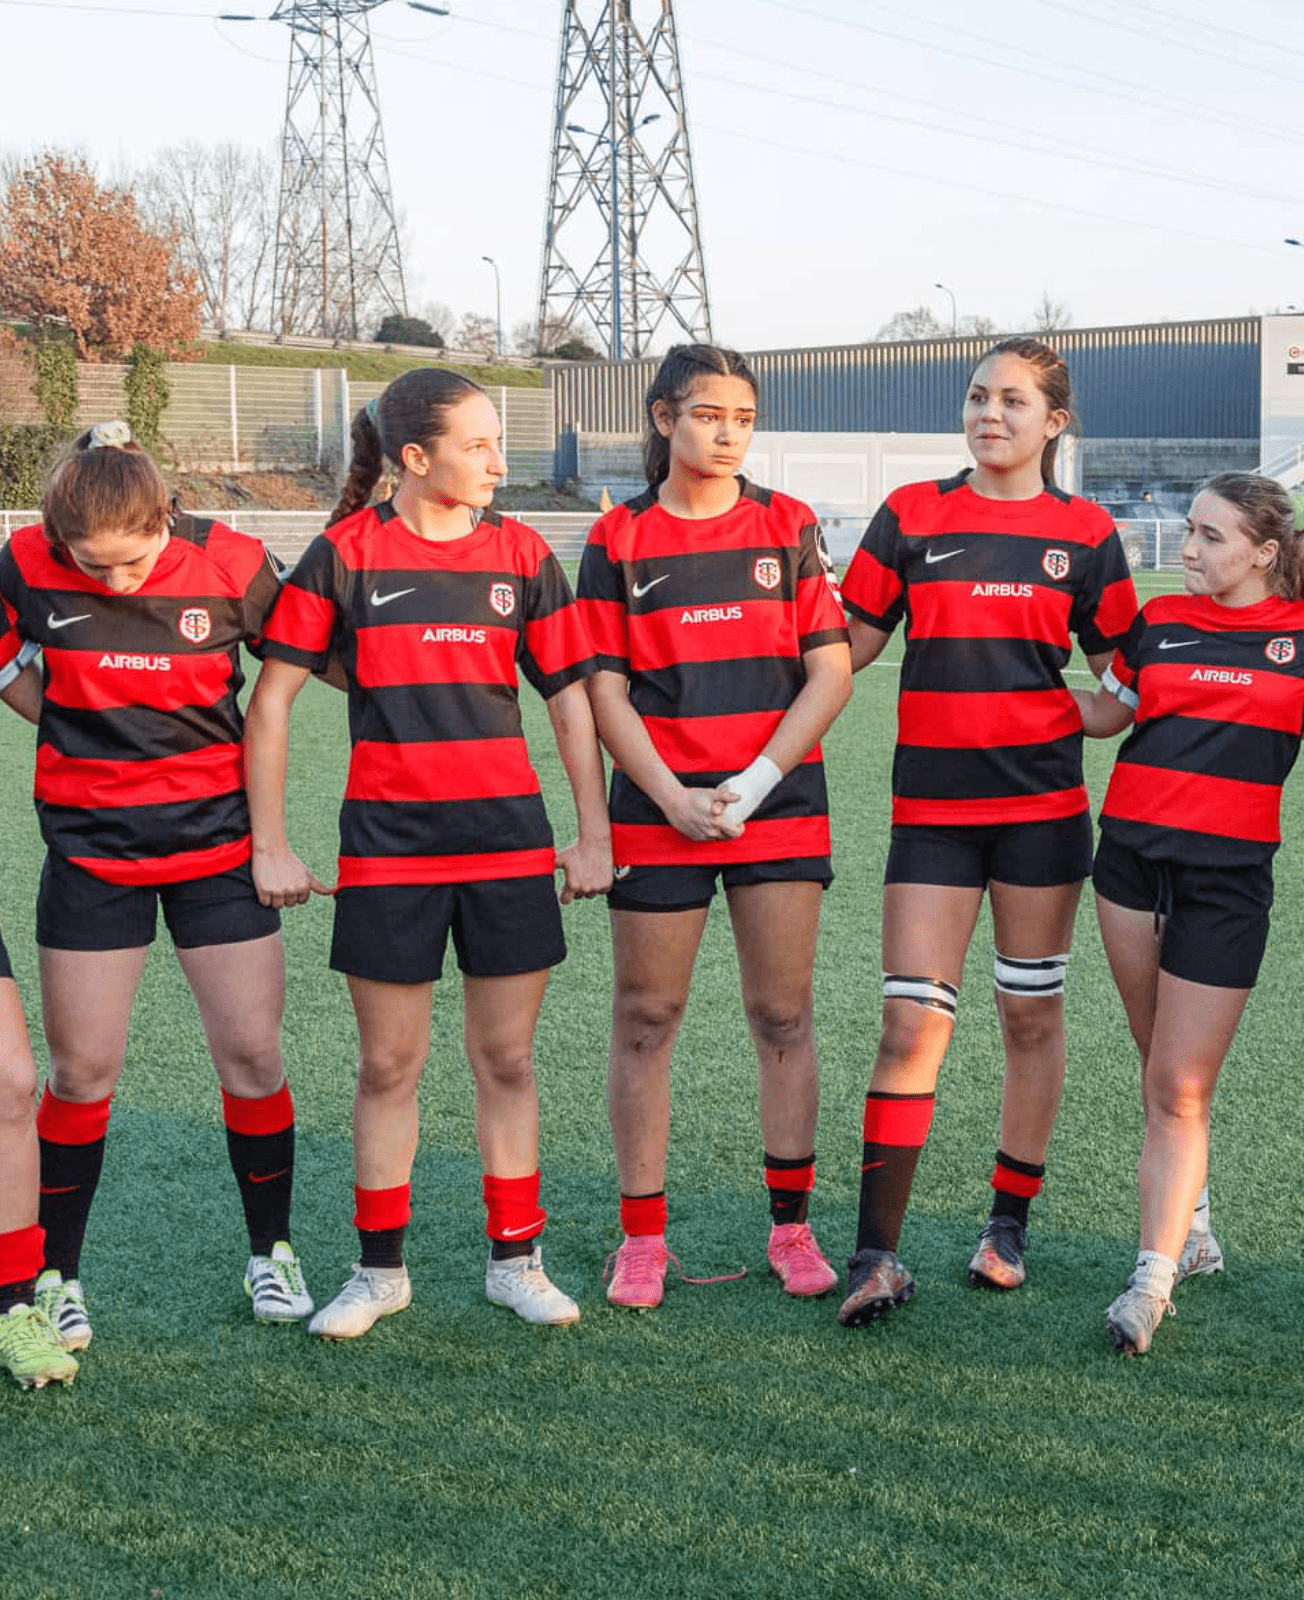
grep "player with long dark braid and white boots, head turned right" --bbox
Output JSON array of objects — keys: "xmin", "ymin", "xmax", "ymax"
[{"xmin": 248, "ymin": 368, "xmax": 611, "ymax": 1339}]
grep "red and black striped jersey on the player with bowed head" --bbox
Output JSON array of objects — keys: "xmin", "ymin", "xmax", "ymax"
[{"xmin": 0, "ymin": 514, "xmax": 280, "ymax": 883}]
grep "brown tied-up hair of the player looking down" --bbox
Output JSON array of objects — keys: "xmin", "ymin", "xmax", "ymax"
[{"xmin": 40, "ymin": 422, "xmax": 170, "ymax": 544}]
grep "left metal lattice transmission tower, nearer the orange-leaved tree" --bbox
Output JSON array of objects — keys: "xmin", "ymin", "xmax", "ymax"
[{"xmin": 272, "ymin": 0, "xmax": 408, "ymax": 339}]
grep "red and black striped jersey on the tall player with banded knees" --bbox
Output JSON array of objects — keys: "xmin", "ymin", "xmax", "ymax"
[{"xmin": 842, "ymin": 472, "xmax": 1136, "ymax": 827}]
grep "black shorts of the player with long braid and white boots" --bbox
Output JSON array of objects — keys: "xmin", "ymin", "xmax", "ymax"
[{"xmin": 331, "ymin": 874, "xmax": 566, "ymax": 984}]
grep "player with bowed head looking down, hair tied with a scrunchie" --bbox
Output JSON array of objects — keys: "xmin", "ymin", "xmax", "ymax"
[{"xmin": 0, "ymin": 422, "xmax": 312, "ymax": 1350}]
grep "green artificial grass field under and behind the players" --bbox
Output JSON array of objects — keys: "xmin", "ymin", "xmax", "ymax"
[{"xmin": 0, "ymin": 569, "xmax": 1304, "ymax": 1600}]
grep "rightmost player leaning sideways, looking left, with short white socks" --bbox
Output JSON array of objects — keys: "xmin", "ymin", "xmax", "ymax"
[{"xmin": 1074, "ymin": 472, "xmax": 1304, "ymax": 1355}]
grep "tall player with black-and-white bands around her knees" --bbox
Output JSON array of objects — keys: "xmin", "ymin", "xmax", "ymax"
[{"xmin": 838, "ymin": 339, "xmax": 1136, "ymax": 1326}]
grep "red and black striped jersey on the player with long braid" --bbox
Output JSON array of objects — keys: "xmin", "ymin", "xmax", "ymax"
[{"xmin": 264, "ymin": 501, "xmax": 594, "ymax": 886}]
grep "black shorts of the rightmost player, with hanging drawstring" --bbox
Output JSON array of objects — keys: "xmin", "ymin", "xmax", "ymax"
[{"xmin": 1094, "ymin": 837, "xmax": 1272, "ymax": 989}]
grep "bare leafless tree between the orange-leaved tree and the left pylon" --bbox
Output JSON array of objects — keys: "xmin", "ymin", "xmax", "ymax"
[{"xmin": 136, "ymin": 141, "xmax": 277, "ymax": 328}]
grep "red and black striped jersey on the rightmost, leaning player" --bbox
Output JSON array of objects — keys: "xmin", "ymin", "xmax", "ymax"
[{"xmin": 1101, "ymin": 595, "xmax": 1304, "ymax": 867}]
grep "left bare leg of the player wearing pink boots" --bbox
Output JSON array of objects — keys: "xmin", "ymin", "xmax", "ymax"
[{"xmin": 606, "ymin": 907, "xmax": 707, "ymax": 1195}]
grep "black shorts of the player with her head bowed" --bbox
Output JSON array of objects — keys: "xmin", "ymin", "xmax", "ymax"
[{"xmin": 37, "ymin": 853, "xmax": 280, "ymax": 950}]
